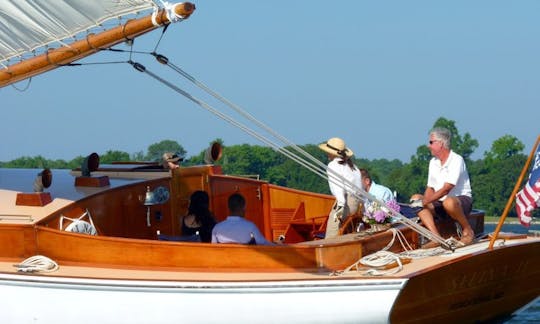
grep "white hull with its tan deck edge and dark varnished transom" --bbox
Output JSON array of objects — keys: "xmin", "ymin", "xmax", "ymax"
[{"xmin": 0, "ymin": 241, "xmax": 540, "ymax": 323}]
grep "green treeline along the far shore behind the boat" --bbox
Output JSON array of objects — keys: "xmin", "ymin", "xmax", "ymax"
[{"xmin": 0, "ymin": 118, "xmax": 539, "ymax": 217}]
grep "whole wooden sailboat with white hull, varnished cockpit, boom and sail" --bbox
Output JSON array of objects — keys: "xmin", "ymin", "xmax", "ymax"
[{"xmin": 0, "ymin": 0, "xmax": 540, "ymax": 323}]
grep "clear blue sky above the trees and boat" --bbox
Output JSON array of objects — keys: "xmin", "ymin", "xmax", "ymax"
[{"xmin": 0, "ymin": 0, "xmax": 540, "ymax": 165}]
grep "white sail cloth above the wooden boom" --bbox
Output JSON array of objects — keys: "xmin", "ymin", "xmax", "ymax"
[{"xmin": 0, "ymin": 0, "xmax": 155, "ymax": 63}]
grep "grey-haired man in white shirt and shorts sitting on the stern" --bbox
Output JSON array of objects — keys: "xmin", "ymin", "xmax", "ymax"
[{"xmin": 413, "ymin": 128, "xmax": 474, "ymax": 245}]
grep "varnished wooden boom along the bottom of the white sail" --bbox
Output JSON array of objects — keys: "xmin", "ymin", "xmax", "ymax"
[{"xmin": 0, "ymin": 2, "xmax": 195, "ymax": 87}]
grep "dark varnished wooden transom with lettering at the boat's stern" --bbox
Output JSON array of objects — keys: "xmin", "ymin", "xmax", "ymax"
[{"xmin": 391, "ymin": 241, "xmax": 540, "ymax": 323}]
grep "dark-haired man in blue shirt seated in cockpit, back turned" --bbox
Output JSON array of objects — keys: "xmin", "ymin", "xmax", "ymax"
[{"xmin": 212, "ymin": 193, "xmax": 273, "ymax": 245}]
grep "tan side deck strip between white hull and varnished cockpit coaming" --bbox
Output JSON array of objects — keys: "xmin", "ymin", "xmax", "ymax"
[{"xmin": 0, "ymin": 237, "xmax": 540, "ymax": 281}]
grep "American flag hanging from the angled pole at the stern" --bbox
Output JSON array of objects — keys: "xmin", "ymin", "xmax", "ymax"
[{"xmin": 516, "ymin": 145, "xmax": 540, "ymax": 227}]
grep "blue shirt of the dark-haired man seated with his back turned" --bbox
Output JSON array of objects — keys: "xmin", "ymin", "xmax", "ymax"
[{"xmin": 212, "ymin": 216, "xmax": 273, "ymax": 245}]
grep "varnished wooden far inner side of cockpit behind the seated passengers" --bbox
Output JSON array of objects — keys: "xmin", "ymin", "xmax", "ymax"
[{"xmin": 29, "ymin": 165, "xmax": 333, "ymax": 246}]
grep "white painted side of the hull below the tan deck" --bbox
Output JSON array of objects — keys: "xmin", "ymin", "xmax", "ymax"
[{"xmin": 0, "ymin": 274, "xmax": 407, "ymax": 323}]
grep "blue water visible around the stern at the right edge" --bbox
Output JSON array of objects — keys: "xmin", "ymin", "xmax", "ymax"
[{"xmin": 484, "ymin": 223, "xmax": 540, "ymax": 324}]
